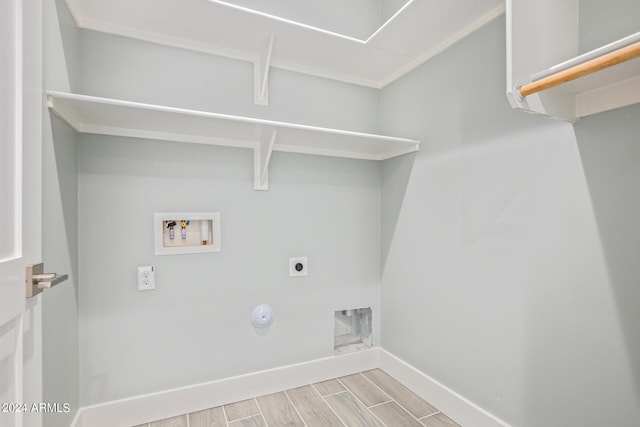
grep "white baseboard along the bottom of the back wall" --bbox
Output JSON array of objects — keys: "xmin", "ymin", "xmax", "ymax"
[{"xmin": 78, "ymin": 349, "xmax": 379, "ymax": 427}]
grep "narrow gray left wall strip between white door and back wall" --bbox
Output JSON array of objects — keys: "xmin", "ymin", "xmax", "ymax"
[{"xmin": 40, "ymin": 0, "xmax": 80, "ymax": 427}]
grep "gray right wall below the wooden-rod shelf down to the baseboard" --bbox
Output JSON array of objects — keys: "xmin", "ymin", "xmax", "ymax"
[{"xmin": 381, "ymin": 18, "xmax": 640, "ymax": 427}]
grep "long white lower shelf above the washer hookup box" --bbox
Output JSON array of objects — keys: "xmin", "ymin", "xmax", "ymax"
[{"xmin": 47, "ymin": 92, "xmax": 419, "ymax": 164}]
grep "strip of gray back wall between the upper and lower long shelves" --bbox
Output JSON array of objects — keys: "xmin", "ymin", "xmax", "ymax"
[{"xmin": 80, "ymin": 31, "xmax": 379, "ymax": 132}]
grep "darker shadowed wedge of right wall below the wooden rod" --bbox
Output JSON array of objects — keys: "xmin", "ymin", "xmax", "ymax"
[{"xmin": 575, "ymin": 105, "xmax": 640, "ymax": 400}]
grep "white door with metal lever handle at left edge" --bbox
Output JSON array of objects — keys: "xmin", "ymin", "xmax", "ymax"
[{"xmin": 0, "ymin": 0, "xmax": 43, "ymax": 427}]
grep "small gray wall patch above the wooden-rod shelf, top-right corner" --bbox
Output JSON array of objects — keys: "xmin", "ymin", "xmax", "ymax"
[{"xmin": 578, "ymin": 0, "xmax": 640, "ymax": 53}]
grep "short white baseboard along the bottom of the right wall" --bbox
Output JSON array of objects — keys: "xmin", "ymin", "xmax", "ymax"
[{"xmin": 379, "ymin": 349, "xmax": 510, "ymax": 427}]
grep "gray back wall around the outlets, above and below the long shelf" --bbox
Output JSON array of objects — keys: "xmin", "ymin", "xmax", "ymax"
[{"xmin": 78, "ymin": 32, "xmax": 381, "ymax": 405}]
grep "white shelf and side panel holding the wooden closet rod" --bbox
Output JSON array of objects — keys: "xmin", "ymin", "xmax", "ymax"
[{"xmin": 507, "ymin": 0, "xmax": 640, "ymax": 121}]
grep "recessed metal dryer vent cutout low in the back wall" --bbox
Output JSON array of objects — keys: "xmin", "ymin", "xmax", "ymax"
[{"xmin": 333, "ymin": 307, "xmax": 373, "ymax": 355}]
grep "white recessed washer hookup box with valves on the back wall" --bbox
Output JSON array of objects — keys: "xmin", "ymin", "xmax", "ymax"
[{"xmin": 153, "ymin": 212, "xmax": 222, "ymax": 255}]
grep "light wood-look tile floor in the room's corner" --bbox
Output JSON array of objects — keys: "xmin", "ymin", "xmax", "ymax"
[{"xmin": 137, "ymin": 369, "xmax": 460, "ymax": 427}]
